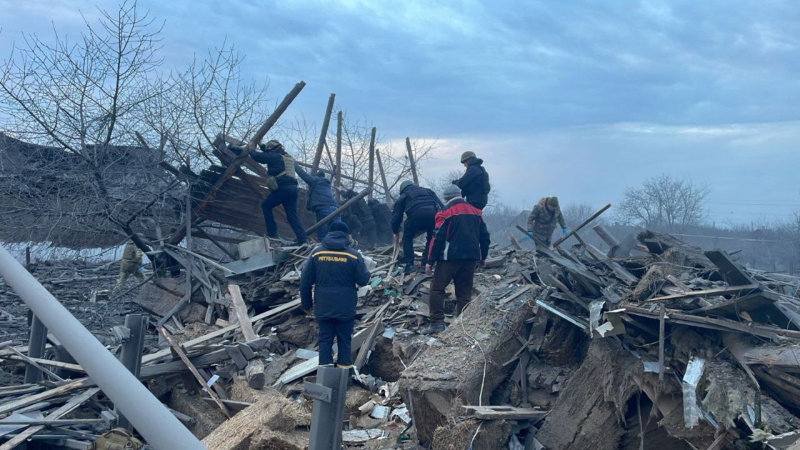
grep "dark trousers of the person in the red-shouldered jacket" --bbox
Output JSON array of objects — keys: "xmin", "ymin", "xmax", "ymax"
[{"xmin": 429, "ymin": 260, "xmax": 478, "ymax": 323}]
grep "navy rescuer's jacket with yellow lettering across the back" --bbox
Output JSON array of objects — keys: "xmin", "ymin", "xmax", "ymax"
[{"xmin": 300, "ymin": 231, "xmax": 369, "ymax": 320}]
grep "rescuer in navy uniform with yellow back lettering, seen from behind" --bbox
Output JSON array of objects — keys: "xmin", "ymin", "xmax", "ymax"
[{"xmin": 300, "ymin": 222, "xmax": 369, "ymax": 368}]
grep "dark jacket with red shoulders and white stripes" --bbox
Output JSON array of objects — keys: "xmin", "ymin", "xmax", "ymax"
[{"xmin": 428, "ymin": 197, "xmax": 491, "ymax": 265}]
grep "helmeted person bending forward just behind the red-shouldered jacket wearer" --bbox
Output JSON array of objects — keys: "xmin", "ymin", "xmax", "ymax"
[{"xmin": 392, "ymin": 180, "xmax": 444, "ymax": 273}]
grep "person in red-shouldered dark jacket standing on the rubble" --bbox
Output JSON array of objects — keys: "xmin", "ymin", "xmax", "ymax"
[{"xmin": 422, "ymin": 186, "xmax": 491, "ymax": 334}]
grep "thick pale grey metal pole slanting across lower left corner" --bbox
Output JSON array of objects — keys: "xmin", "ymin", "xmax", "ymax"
[{"xmin": 0, "ymin": 246, "xmax": 205, "ymax": 450}]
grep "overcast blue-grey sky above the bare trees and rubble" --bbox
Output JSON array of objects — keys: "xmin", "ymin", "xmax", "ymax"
[{"xmin": 0, "ymin": 0, "xmax": 800, "ymax": 225}]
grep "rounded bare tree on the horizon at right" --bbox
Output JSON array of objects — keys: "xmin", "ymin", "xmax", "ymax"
[{"xmin": 617, "ymin": 175, "xmax": 709, "ymax": 231}]
